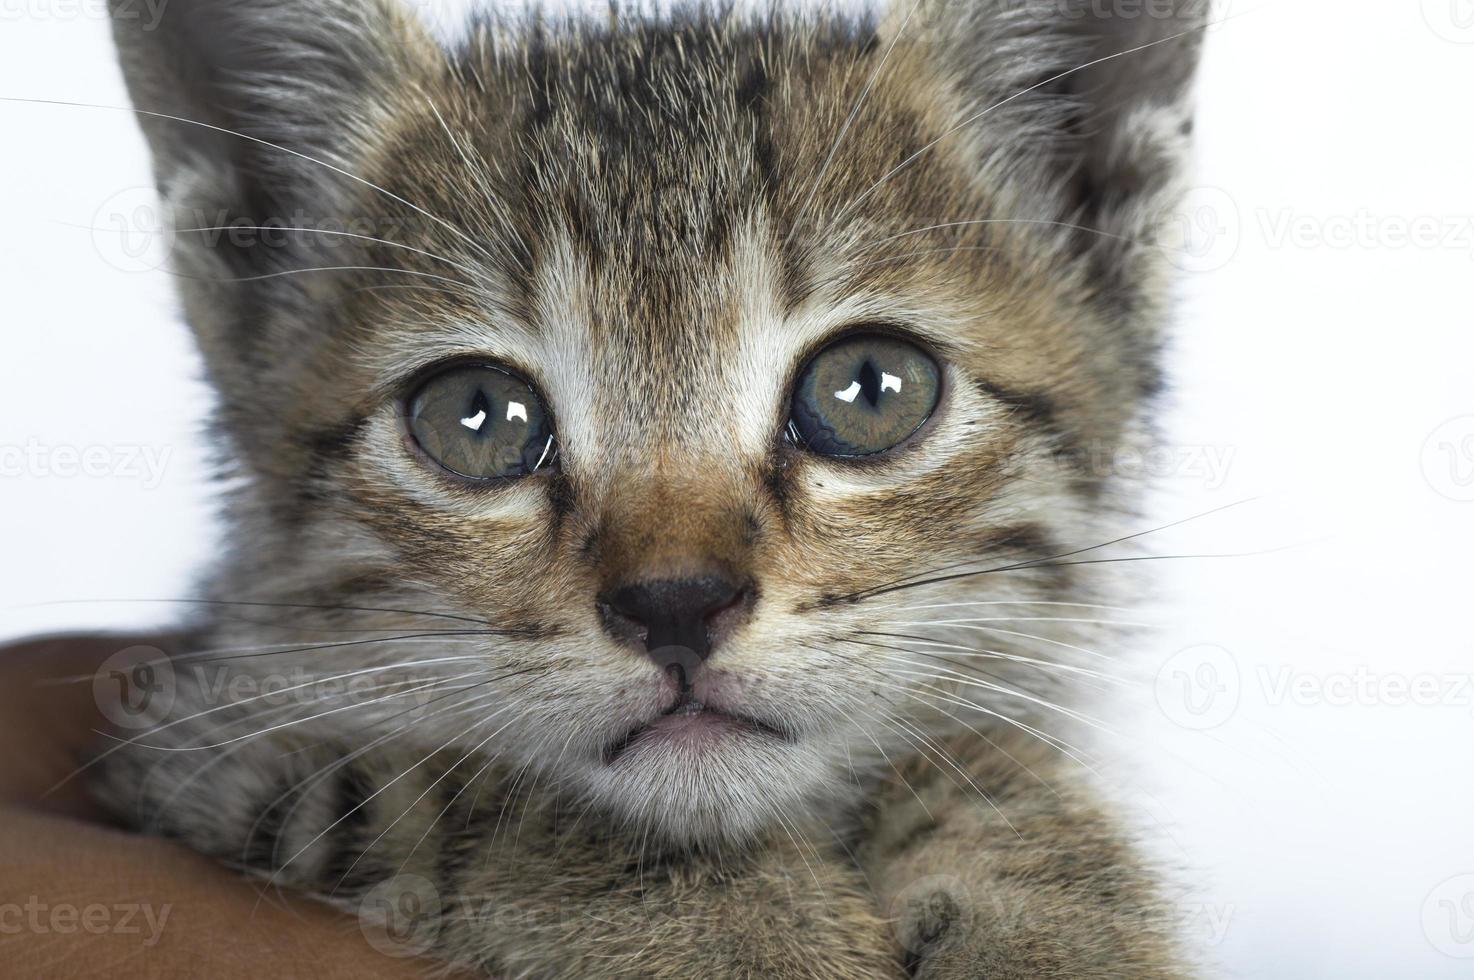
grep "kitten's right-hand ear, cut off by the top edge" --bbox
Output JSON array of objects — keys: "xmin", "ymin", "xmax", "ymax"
[{"xmin": 890, "ymin": 0, "xmax": 1210, "ymax": 249}]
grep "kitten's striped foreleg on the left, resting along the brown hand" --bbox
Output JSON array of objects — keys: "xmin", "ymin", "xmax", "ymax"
[{"xmin": 100, "ymin": 735, "xmax": 904, "ymax": 980}]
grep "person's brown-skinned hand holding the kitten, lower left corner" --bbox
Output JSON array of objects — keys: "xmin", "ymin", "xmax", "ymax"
[{"xmin": 0, "ymin": 635, "xmax": 456, "ymax": 980}]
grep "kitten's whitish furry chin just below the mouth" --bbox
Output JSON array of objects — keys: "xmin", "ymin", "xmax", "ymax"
[{"xmin": 588, "ymin": 730, "xmax": 836, "ymax": 846}]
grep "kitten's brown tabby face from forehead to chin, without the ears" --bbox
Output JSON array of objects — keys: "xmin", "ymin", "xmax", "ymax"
[{"xmin": 112, "ymin": 0, "xmax": 1196, "ymax": 840}]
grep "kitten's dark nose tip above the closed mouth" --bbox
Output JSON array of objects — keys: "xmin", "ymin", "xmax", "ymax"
[{"xmin": 600, "ymin": 575, "xmax": 752, "ymax": 682}]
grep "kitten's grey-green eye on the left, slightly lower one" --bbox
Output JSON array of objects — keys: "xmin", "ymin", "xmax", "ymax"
[{"xmin": 405, "ymin": 364, "xmax": 554, "ymax": 480}]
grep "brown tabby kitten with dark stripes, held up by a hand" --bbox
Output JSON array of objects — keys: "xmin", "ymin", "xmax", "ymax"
[{"xmin": 97, "ymin": 0, "xmax": 1206, "ymax": 980}]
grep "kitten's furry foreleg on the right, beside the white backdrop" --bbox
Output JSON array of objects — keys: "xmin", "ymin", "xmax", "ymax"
[{"xmin": 861, "ymin": 737, "xmax": 1190, "ymax": 980}]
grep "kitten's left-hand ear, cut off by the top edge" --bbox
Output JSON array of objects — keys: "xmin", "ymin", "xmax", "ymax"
[{"xmin": 109, "ymin": 0, "xmax": 435, "ymax": 217}]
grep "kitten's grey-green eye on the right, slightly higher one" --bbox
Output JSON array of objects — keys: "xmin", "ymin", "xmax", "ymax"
[{"xmin": 790, "ymin": 335, "xmax": 942, "ymax": 457}]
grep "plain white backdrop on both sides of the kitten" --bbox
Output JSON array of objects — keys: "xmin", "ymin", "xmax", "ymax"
[{"xmin": 0, "ymin": 0, "xmax": 1474, "ymax": 979}]
